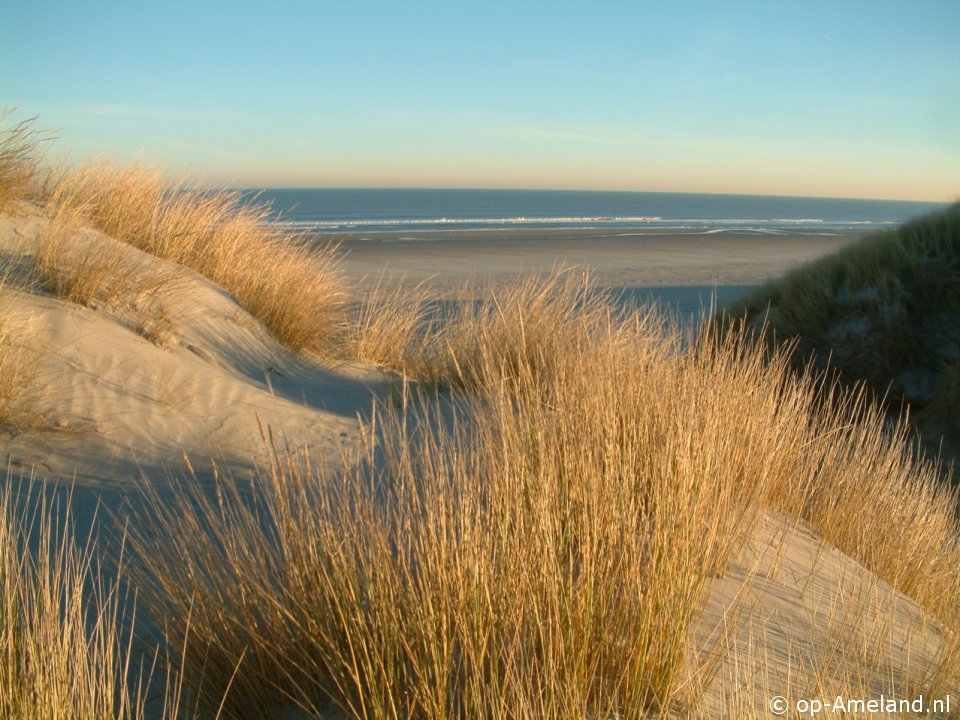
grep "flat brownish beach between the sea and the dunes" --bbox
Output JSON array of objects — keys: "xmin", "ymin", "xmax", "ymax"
[{"xmin": 335, "ymin": 228, "xmax": 864, "ymax": 310}]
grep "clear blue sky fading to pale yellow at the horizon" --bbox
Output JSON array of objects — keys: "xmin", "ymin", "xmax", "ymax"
[{"xmin": 0, "ymin": 0, "xmax": 960, "ymax": 201}]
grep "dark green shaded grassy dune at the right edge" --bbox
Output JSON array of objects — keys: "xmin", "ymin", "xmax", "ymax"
[{"xmin": 725, "ymin": 204, "xmax": 960, "ymax": 446}]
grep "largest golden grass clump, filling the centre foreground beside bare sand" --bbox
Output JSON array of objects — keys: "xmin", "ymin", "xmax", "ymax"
[{"xmin": 125, "ymin": 278, "xmax": 960, "ymax": 720}]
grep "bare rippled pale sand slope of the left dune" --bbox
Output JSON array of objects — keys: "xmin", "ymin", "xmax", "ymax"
[{"xmin": 0, "ymin": 210, "xmax": 389, "ymax": 484}]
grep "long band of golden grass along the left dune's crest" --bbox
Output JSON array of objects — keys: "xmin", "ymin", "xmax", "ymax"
[{"xmin": 47, "ymin": 164, "xmax": 346, "ymax": 356}]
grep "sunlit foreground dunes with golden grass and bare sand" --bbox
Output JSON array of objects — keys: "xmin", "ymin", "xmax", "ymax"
[{"xmin": 0, "ymin": 115, "xmax": 960, "ymax": 720}]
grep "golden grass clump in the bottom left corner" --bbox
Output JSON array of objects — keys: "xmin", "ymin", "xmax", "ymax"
[{"xmin": 0, "ymin": 476, "xmax": 177, "ymax": 720}]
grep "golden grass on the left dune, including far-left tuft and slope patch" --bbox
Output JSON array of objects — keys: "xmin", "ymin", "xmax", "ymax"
[{"xmin": 0, "ymin": 114, "xmax": 345, "ymax": 357}]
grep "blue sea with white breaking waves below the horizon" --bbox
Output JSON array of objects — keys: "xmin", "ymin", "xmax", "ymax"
[{"xmin": 250, "ymin": 189, "xmax": 946, "ymax": 240}]
